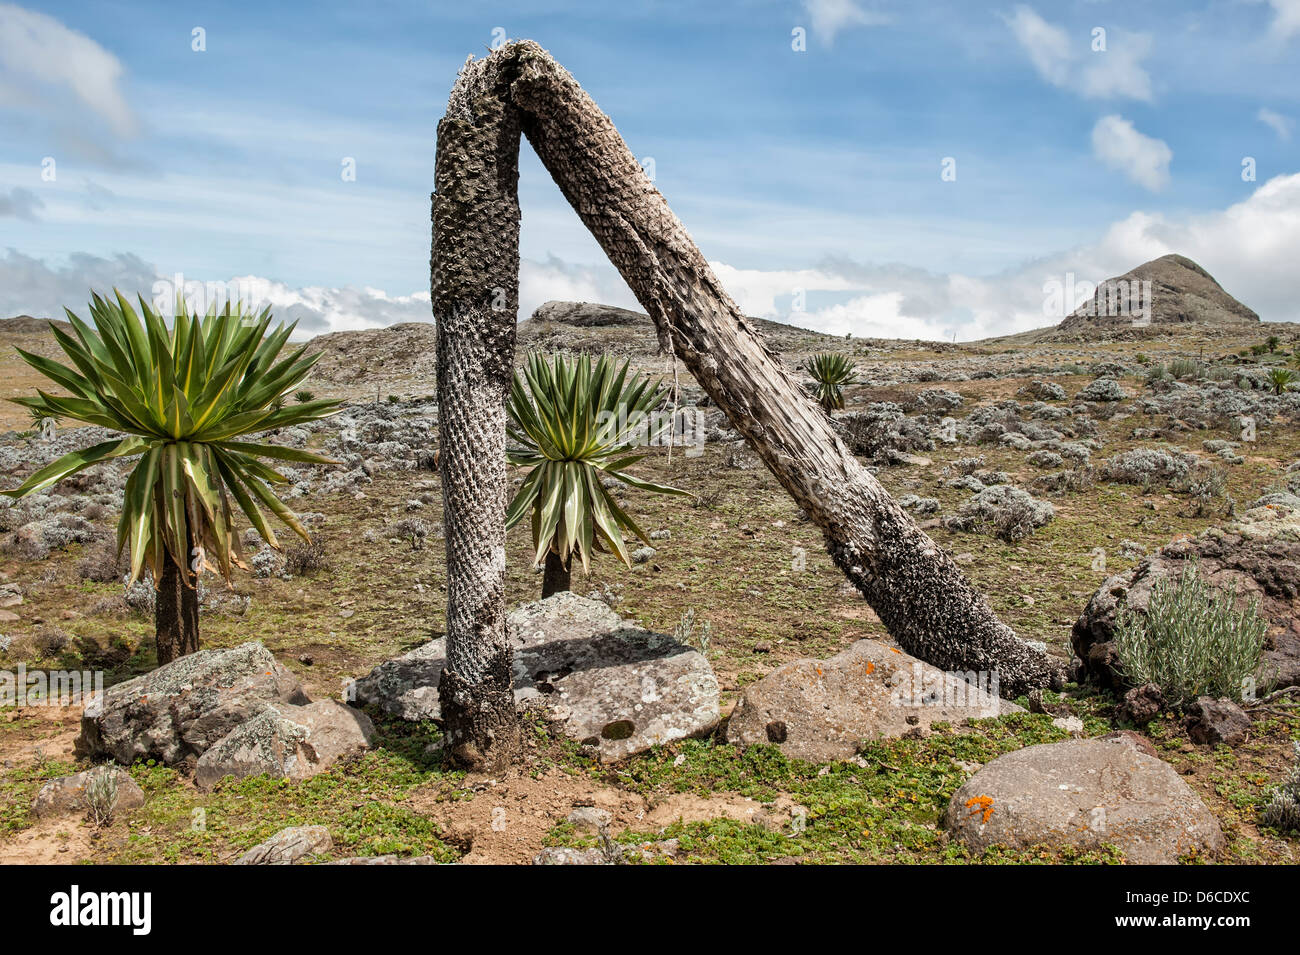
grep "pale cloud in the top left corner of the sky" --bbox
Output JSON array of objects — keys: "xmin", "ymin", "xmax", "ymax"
[{"xmin": 0, "ymin": 4, "xmax": 138, "ymax": 136}]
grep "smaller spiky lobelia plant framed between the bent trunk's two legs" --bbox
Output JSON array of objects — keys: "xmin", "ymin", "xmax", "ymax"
[{"xmin": 506, "ymin": 352, "xmax": 686, "ymax": 596}]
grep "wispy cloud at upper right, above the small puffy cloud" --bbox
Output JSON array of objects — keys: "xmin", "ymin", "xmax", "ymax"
[{"xmin": 1005, "ymin": 5, "xmax": 1152, "ymax": 103}]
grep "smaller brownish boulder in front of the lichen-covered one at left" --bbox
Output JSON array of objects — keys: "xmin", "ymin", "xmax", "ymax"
[{"xmin": 194, "ymin": 700, "xmax": 374, "ymax": 789}]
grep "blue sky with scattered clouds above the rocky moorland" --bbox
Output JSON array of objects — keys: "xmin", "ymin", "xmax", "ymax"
[{"xmin": 0, "ymin": 0, "xmax": 1300, "ymax": 339}]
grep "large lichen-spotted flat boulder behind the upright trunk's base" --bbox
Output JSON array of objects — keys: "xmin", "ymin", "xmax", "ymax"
[{"xmin": 355, "ymin": 592, "xmax": 719, "ymax": 759}]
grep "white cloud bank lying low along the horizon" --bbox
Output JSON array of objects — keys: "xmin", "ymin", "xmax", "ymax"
[{"xmin": 10, "ymin": 173, "xmax": 1300, "ymax": 342}]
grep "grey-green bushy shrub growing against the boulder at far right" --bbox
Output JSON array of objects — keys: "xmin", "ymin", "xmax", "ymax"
[{"xmin": 1115, "ymin": 561, "xmax": 1269, "ymax": 703}]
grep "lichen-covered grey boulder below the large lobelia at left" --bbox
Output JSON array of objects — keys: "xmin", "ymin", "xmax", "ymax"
[{"xmin": 75, "ymin": 642, "xmax": 309, "ymax": 765}]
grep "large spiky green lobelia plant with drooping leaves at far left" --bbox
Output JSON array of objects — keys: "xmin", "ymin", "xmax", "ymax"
[{"xmin": 4, "ymin": 290, "xmax": 339, "ymax": 664}]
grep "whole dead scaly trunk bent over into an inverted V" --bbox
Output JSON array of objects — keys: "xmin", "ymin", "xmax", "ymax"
[{"xmin": 433, "ymin": 40, "xmax": 1057, "ymax": 769}]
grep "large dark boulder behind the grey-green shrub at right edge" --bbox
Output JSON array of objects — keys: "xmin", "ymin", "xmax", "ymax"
[{"xmin": 1071, "ymin": 494, "xmax": 1300, "ymax": 687}]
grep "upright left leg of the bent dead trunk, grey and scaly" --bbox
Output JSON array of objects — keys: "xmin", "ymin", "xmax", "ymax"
[{"xmin": 430, "ymin": 57, "xmax": 520, "ymax": 769}]
